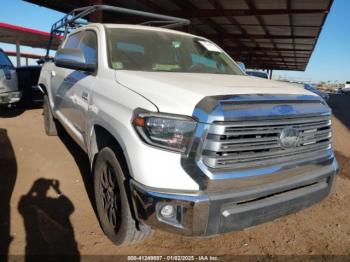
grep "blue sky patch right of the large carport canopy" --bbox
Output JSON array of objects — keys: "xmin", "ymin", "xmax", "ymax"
[{"xmin": 274, "ymin": 0, "xmax": 350, "ymax": 83}]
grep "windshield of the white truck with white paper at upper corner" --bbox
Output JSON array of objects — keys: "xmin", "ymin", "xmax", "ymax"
[{"xmin": 107, "ymin": 28, "xmax": 243, "ymax": 75}]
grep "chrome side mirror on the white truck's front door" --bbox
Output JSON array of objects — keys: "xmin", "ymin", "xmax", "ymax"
[{"xmin": 54, "ymin": 48, "xmax": 96, "ymax": 72}]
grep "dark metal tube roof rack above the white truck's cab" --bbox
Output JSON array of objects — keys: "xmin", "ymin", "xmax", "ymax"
[{"xmin": 46, "ymin": 5, "xmax": 191, "ymax": 57}]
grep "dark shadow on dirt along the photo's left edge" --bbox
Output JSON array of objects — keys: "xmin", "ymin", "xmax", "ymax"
[{"xmin": 0, "ymin": 128, "xmax": 17, "ymax": 261}]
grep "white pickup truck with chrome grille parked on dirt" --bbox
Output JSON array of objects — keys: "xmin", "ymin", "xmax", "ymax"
[{"xmin": 39, "ymin": 17, "xmax": 338, "ymax": 244}]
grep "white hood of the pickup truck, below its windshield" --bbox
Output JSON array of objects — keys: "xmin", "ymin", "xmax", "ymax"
[{"xmin": 116, "ymin": 70, "xmax": 317, "ymax": 115}]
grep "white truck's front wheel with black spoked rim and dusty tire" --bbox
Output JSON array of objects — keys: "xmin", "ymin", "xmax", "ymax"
[{"xmin": 94, "ymin": 147, "xmax": 152, "ymax": 245}]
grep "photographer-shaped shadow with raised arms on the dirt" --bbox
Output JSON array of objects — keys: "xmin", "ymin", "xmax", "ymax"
[{"xmin": 18, "ymin": 178, "xmax": 80, "ymax": 261}]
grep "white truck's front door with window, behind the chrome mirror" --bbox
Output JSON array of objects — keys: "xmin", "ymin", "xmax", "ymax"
[{"xmin": 52, "ymin": 30, "xmax": 97, "ymax": 146}]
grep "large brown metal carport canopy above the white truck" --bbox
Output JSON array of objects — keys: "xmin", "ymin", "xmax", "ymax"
[{"xmin": 26, "ymin": 0, "xmax": 333, "ymax": 71}]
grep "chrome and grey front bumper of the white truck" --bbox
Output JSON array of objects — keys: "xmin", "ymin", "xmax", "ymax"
[{"xmin": 130, "ymin": 158, "xmax": 338, "ymax": 236}]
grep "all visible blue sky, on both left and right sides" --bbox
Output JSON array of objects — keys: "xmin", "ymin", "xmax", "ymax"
[{"xmin": 0, "ymin": 0, "xmax": 350, "ymax": 83}]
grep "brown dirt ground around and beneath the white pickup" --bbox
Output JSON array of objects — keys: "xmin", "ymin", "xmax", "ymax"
[{"xmin": 0, "ymin": 95, "xmax": 350, "ymax": 260}]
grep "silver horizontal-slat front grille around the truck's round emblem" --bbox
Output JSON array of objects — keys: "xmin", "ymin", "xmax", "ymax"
[{"xmin": 203, "ymin": 115, "xmax": 332, "ymax": 168}]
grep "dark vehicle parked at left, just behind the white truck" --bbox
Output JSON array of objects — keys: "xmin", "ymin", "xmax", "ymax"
[{"xmin": 17, "ymin": 66, "xmax": 44, "ymax": 106}]
